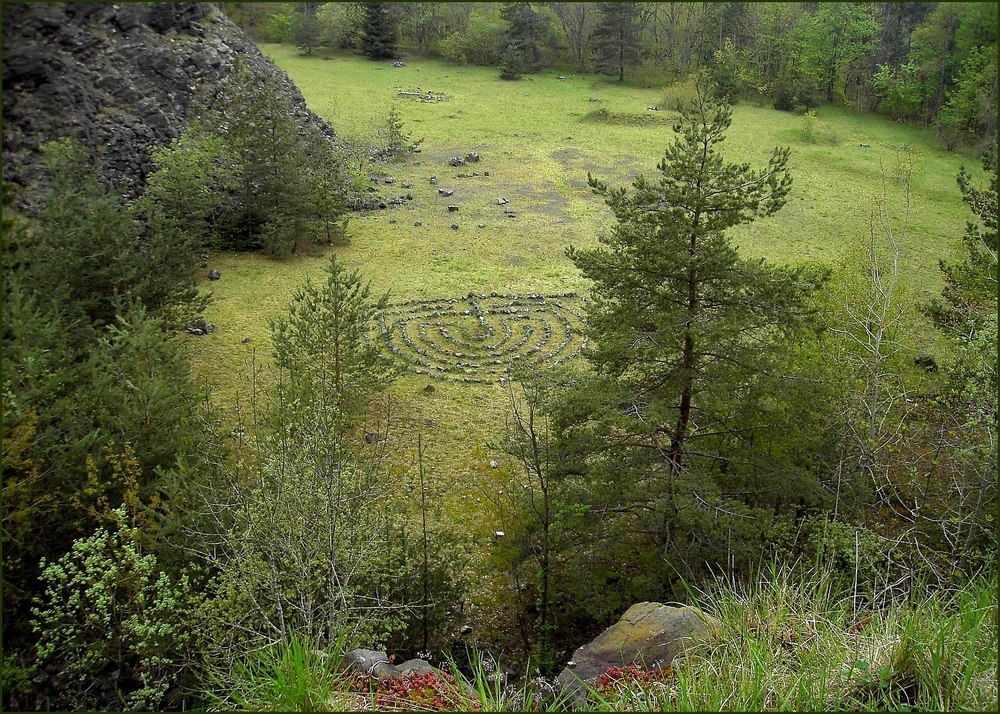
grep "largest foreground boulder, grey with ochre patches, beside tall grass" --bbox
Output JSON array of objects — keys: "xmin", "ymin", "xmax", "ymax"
[{"xmin": 556, "ymin": 602, "xmax": 719, "ymax": 705}]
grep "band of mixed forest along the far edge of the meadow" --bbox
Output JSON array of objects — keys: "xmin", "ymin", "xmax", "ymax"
[{"xmin": 225, "ymin": 2, "xmax": 997, "ymax": 151}]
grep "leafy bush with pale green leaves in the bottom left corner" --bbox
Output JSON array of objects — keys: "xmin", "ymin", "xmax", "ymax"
[{"xmin": 32, "ymin": 506, "xmax": 196, "ymax": 710}]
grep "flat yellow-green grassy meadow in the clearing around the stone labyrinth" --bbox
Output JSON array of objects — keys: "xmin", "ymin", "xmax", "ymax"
[{"xmin": 190, "ymin": 45, "xmax": 976, "ymax": 632}]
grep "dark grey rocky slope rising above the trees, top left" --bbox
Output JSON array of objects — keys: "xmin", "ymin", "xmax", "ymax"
[{"xmin": 3, "ymin": 3, "xmax": 333, "ymax": 196}]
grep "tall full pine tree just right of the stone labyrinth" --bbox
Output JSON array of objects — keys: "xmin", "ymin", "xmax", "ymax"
[{"xmin": 561, "ymin": 78, "xmax": 824, "ymax": 557}]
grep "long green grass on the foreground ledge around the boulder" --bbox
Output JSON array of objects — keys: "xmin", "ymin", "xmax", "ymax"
[{"xmin": 203, "ymin": 566, "xmax": 997, "ymax": 711}]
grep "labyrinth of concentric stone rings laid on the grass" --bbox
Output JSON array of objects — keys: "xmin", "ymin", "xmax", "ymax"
[{"xmin": 379, "ymin": 293, "xmax": 587, "ymax": 382}]
